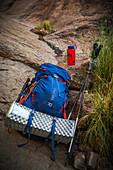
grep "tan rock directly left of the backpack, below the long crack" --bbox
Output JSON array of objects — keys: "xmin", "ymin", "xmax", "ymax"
[{"xmin": 0, "ymin": 57, "xmax": 35, "ymax": 114}]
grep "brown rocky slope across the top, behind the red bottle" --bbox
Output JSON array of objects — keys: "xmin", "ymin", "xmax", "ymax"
[{"xmin": 0, "ymin": 0, "xmax": 113, "ymax": 61}]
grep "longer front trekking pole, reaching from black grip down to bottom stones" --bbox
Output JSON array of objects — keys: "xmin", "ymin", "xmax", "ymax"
[{"xmin": 65, "ymin": 43, "xmax": 102, "ymax": 165}]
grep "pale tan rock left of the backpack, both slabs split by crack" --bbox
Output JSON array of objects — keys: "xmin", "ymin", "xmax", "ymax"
[{"xmin": 0, "ymin": 14, "xmax": 57, "ymax": 113}]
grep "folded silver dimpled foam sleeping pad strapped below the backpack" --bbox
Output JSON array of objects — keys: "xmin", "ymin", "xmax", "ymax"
[{"xmin": 5, "ymin": 102, "xmax": 75, "ymax": 143}]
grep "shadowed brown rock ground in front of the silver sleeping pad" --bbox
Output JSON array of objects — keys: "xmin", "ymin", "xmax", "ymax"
[{"xmin": 0, "ymin": 120, "xmax": 73, "ymax": 170}]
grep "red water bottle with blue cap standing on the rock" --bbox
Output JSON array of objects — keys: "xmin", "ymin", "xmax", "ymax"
[{"xmin": 67, "ymin": 45, "xmax": 77, "ymax": 65}]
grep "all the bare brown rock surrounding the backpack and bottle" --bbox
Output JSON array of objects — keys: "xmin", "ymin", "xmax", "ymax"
[{"xmin": 0, "ymin": 0, "xmax": 113, "ymax": 170}]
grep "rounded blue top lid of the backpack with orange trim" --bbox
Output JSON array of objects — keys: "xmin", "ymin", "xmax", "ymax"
[{"xmin": 35, "ymin": 63, "xmax": 71, "ymax": 82}]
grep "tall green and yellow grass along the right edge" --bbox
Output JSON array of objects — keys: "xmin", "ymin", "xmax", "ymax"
[{"xmin": 80, "ymin": 32, "xmax": 113, "ymax": 158}]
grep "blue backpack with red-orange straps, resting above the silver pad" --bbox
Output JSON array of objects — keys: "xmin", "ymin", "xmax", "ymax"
[{"xmin": 22, "ymin": 63, "xmax": 71, "ymax": 119}]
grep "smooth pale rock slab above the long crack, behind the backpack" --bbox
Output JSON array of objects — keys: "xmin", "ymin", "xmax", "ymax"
[{"xmin": 0, "ymin": 14, "xmax": 57, "ymax": 70}]
